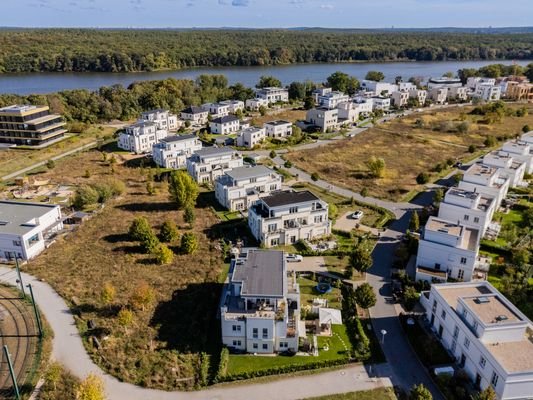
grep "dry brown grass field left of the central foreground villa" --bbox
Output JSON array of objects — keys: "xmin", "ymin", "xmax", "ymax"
[{"xmin": 20, "ymin": 151, "xmax": 233, "ymax": 389}]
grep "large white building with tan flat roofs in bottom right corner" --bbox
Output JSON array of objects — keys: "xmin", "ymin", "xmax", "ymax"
[{"xmin": 420, "ymin": 281, "xmax": 533, "ymax": 400}]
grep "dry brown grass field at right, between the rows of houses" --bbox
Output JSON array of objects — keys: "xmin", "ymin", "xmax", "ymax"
[{"xmin": 286, "ymin": 104, "xmax": 533, "ymax": 200}]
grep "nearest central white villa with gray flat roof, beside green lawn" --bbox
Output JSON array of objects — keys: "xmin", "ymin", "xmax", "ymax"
[{"xmin": 220, "ymin": 250, "xmax": 305, "ymax": 354}]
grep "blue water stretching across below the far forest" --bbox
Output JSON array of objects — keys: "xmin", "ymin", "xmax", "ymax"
[{"xmin": 0, "ymin": 60, "xmax": 531, "ymax": 95}]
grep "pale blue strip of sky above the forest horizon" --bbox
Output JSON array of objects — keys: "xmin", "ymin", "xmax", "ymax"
[{"xmin": 0, "ymin": 0, "xmax": 533, "ymax": 28}]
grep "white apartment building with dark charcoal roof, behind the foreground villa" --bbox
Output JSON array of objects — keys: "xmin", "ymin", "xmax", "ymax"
[{"xmin": 248, "ymin": 190, "xmax": 331, "ymax": 247}]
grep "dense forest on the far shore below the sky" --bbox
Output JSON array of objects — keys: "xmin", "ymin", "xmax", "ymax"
[{"xmin": 0, "ymin": 29, "xmax": 533, "ymax": 73}]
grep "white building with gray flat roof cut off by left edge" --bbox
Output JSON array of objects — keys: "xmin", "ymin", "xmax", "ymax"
[{"xmin": 0, "ymin": 201, "xmax": 63, "ymax": 260}]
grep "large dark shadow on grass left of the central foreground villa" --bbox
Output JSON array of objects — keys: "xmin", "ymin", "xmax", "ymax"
[{"xmin": 150, "ymin": 282, "xmax": 222, "ymax": 354}]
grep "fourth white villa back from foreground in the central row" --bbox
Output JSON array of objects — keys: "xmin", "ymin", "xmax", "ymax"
[{"xmin": 187, "ymin": 147, "xmax": 244, "ymax": 183}]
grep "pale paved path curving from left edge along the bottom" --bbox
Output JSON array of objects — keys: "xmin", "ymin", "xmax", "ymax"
[{"xmin": 0, "ymin": 267, "xmax": 391, "ymax": 400}]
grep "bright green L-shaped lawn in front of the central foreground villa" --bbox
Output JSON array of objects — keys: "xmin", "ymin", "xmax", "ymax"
[{"xmin": 227, "ymin": 325, "xmax": 351, "ymax": 376}]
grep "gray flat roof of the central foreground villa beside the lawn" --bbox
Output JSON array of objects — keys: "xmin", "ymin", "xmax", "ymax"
[{"xmin": 231, "ymin": 250, "xmax": 286, "ymax": 297}]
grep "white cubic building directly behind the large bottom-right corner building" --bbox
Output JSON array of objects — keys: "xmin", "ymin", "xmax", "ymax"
[{"xmin": 416, "ymin": 217, "xmax": 480, "ymax": 283}]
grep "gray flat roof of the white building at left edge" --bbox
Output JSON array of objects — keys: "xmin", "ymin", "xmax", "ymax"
[{"xmin": 0, "ymin": 201, "xmax": 59, "ymax": 235}]
